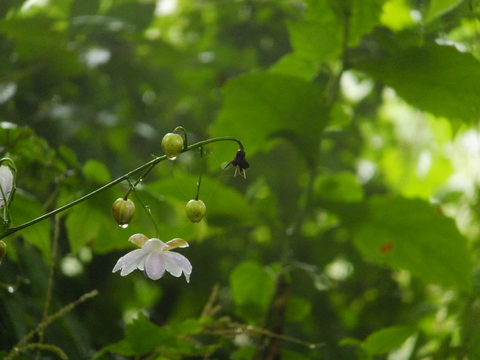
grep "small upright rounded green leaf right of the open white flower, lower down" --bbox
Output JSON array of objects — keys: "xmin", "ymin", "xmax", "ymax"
[{"xmin": 230, "ymin": 261, "xmax": 275, "ymax": 320}]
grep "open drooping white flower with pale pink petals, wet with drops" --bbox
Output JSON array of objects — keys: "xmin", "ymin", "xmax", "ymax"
[{"xmin": 112, "ymin": 234, "xmax": 192, "ymax": 282}]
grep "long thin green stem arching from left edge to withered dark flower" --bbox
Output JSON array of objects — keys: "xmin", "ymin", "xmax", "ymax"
[{"xmin": 0, "ymin": 136, "xmax": 244, "ymax": 239}]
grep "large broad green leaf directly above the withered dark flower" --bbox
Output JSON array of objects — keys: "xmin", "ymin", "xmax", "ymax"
[{"xmin": 214, "ymin": 72, "xmax": 328, "ymax": 157}]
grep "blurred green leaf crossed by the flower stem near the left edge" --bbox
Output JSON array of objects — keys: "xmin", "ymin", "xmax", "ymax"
[{"xmin": 9, "ymin": 193, "xmax": 50, "ymax": 262}]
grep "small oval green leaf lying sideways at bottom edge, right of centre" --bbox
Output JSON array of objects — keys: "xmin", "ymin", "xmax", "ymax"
[{"xmin": 364, "ymin": 326, "xmax": 417, "ymax": 355}]
